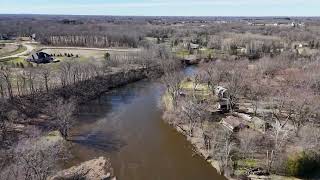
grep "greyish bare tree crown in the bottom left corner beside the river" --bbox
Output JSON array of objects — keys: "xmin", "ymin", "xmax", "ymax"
[{"xmin": 0, "ymin": 131, "xmax": 66, "ymax": 180}]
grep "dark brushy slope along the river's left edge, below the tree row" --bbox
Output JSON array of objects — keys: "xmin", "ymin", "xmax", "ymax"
[{"xmin": 3, "ymin": 66, "xmax": 150, "ymax": 119}]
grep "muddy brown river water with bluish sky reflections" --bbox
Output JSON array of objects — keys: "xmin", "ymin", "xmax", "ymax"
[{"xmin": 67, "ymin": 69, "xmax": 225, "ymax": 180}]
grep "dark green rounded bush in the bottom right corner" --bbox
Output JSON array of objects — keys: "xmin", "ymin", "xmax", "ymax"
[{"xmin": 286, "ymin": 151, "xmax": 320, "ymax": 177}]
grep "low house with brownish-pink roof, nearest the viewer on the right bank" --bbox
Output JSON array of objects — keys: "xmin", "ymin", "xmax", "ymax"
[{"xmin": 220, "ymin": 116, "xmax": 249, "ymax": 132}]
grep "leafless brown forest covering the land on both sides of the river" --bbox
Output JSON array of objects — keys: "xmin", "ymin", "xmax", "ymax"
[{"xmin": 0, "ymin": 15, "xmax": 320, "ymax": 180}]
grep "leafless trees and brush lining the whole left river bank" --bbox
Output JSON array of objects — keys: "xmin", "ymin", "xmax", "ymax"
[{"xmin": 0, "ymin": 43, "xmax": 180, "ymax": 179}]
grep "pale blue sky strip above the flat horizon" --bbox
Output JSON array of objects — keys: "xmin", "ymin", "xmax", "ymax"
[{"xmin": 0, "ymin": 0, "xmax": 320, "ymax": 16}]
